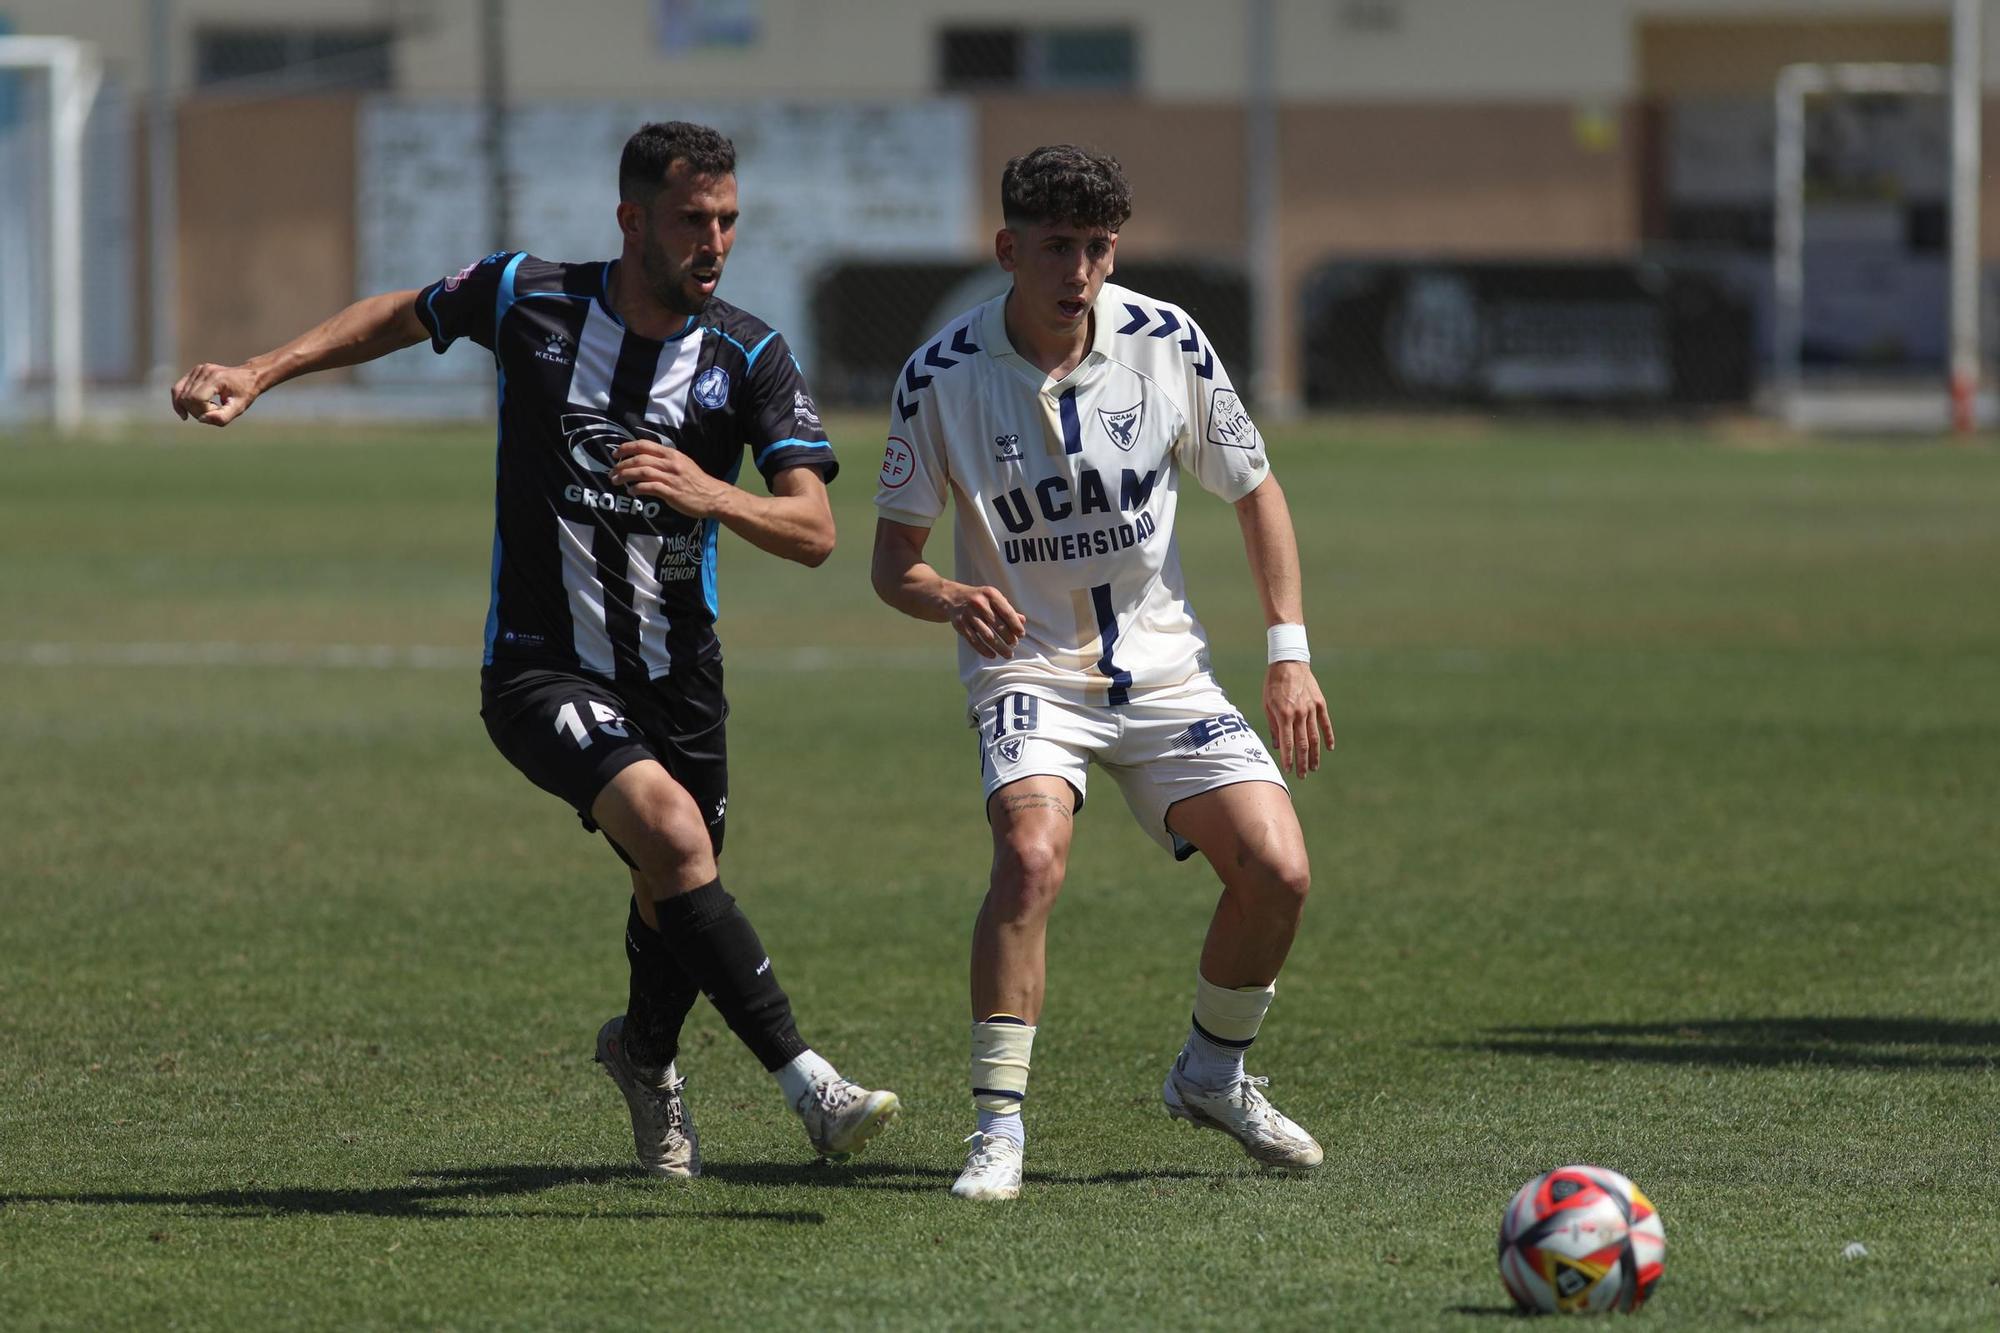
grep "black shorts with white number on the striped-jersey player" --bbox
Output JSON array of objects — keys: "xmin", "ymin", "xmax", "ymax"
[{"xmin": 480, "ymin": 654, "xmax": 730, "ymax": 852}]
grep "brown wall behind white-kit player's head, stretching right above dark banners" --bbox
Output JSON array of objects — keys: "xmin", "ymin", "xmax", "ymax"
[{"xmin": 980, "ymin": 98, "xmax": 1640, "ymax": 394}]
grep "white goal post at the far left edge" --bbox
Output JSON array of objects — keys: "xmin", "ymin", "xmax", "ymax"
[{"xmin": 0, "ymin": 36, "xmax": 102, "ymax": 434}]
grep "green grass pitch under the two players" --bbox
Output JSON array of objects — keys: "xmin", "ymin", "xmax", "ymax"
[{"xmin": 0, "ymin": 420, "xmax": 2000, "ymax": 1329}]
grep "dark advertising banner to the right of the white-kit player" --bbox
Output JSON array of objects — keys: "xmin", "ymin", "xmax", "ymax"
[{"xmin": 1304, "ymin": 260, "xmax": 1750, "ymax": 410}]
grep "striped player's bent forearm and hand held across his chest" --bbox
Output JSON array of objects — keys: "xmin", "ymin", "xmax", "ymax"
[{"xmin": 612, "ymin": 440, "xmax": 834, "ymax": 566}]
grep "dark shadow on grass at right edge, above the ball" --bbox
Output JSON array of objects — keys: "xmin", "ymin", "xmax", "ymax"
[{"xmin": 1448, "ymin": 1017, "xmax": 2000, "ymax": 1069}]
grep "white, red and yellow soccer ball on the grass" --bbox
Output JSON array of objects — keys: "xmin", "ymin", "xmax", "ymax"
[{"xmin": 1500, "ymin": 1167, "xmax": 1666, "ymax": 1315}]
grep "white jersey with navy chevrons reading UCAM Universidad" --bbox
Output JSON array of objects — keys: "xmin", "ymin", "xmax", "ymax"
[{"xmin": 876, "ymin": 284, "xmax": 1270, "ymax": 705}]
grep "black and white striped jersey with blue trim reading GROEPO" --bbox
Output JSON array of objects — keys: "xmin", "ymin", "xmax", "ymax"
[{"xmin": 416, "ymin": 250, "xmax": 838, "ymax": 681}]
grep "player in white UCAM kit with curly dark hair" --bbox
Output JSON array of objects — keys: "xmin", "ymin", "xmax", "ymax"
[{"xmin": 872, "ymin": 146, "xmax": 1334, "ymax": 1199}]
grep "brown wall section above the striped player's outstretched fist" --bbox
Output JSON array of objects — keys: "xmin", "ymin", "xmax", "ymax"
[{"xmin": 178, "ymin": 96, "xmax": 356, "ymax": 368}]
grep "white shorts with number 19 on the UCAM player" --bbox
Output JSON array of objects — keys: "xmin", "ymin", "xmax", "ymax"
[{"xmin": 972, "ymin": 675, "xmax": 1284, "ymax": 861}]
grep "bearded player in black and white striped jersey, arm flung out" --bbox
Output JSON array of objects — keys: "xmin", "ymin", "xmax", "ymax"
[{"xmin": 172, "ymin": 122, "xmax": 898, "ymax": 1177}]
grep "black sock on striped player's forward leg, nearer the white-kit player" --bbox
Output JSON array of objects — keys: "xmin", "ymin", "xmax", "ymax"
[{"xmin": 652, "ymin": 879, "xmax": 808, "ymax": 1069}]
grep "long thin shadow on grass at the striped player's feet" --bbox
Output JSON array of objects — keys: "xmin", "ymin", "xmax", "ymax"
[{"xmin": 0, "ymin": 1165, "xmax": 826, "ymax": 1227}]
